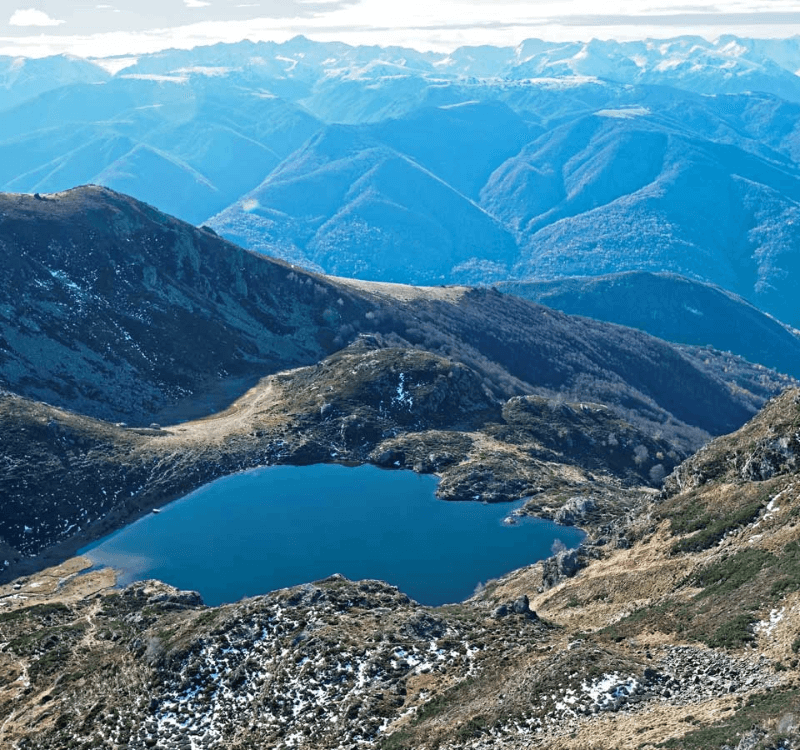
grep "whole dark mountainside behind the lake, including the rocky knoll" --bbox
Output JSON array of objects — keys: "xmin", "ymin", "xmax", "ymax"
[{"xmin": 0, "ymin": 187, "xmax": 796, "ymax": 561}]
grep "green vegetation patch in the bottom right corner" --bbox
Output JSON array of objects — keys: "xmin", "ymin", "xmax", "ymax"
[{"xmin": 658, "ymin": 689, "xmax": 800, "ymax": 750}]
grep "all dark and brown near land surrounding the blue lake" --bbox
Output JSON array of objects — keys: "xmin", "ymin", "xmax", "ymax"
[{"xmin": 0, "ymin": 187, "xmax": 800, "ymax": 750}]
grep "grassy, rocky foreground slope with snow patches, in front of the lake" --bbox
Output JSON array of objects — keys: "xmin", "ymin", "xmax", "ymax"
[{"xmin": 0, "ymin": 391, "xmax": 800, "ymax": 748}]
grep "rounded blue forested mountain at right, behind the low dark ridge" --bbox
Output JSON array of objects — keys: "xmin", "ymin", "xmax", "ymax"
[{"xmin": 482, "ymin": 111, "xmax": 800, "ymax": 322}]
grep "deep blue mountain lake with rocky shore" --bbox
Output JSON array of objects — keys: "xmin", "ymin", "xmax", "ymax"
[{"xmin": 81, "ymin": 464, "xmax": 584, "ymax": 605}]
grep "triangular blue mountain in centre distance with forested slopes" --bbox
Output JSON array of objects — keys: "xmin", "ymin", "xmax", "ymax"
[{"xmin": 208, "ymin": 116, "xmax": 516, "ymax": 284}]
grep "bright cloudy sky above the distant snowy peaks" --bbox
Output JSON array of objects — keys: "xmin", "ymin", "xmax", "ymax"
[{"xmin": 0, "ymin": 0, "xmax": 800, "ymax": 57}]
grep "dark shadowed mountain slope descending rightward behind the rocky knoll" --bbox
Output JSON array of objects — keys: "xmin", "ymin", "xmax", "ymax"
[{"xmin": 0, "ymin": 187, "xmax": 789, "ymax": 444}]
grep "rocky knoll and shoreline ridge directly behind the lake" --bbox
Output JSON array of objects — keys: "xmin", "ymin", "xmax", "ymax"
[{"xmin": 0, "ymin": 341, "xmax": 681, "ymax": 579}]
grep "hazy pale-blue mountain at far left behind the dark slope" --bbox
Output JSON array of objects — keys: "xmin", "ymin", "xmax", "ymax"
[{"xmin": 0, "ymin": 76, "xmax": 321, "ymax": 223}]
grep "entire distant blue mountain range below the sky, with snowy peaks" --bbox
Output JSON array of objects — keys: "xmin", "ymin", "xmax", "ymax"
[{"xmin": 0, "ymin": 37, "xmax": 800, "ymax": 338}]
